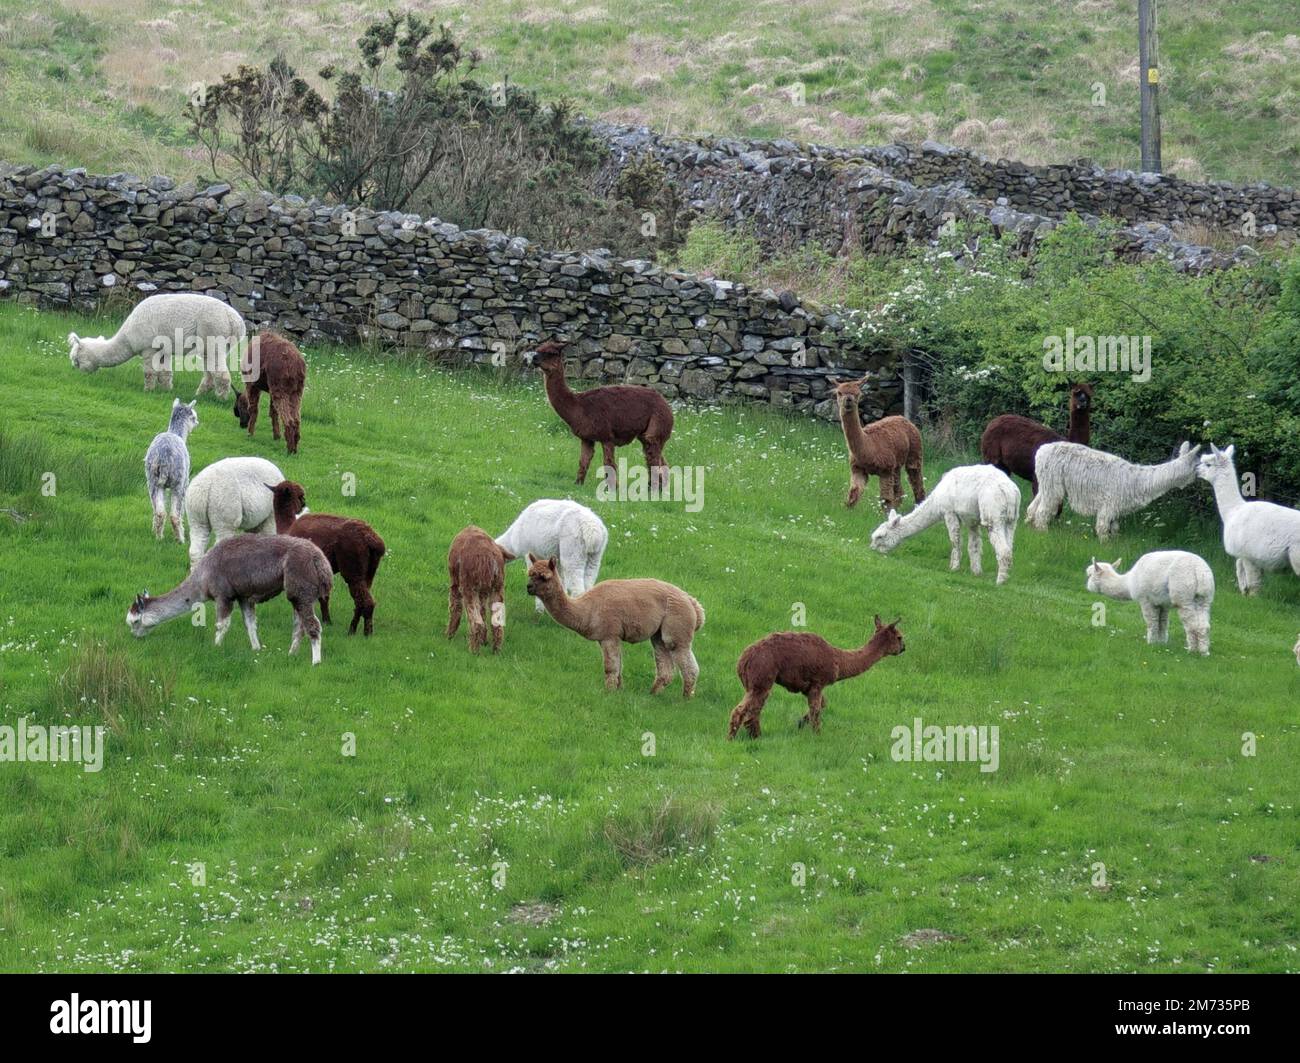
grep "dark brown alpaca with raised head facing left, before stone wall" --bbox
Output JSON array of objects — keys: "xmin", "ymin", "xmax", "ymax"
[{"xmin": 536, "ymin": 339, "xmax": 672, "ymax": 489}]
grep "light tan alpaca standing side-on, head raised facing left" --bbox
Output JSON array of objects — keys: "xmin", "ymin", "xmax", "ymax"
[{"xmin": 528, "ymin": 554, "xmax": 705, "ymax": 698}]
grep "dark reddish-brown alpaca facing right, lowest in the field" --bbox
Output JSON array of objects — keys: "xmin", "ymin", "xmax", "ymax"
[{"xmin": 727, "ymin": 616, "xmax": 904, "ymax": 738}]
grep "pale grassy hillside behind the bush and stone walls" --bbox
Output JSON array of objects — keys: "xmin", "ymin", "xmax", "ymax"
[{"xmin": 0, "ymin": 0, "xmax": 1300, "ymax": 183}]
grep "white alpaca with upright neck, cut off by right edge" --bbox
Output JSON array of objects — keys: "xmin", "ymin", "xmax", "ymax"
[{"xmin": 1196, "ymin": 443, "xmax": 1300, "ymax": 597}]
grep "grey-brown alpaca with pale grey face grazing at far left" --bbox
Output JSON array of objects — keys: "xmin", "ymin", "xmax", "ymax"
[{"xmin": 126, "ymin": 535, "xmax": 334, "ymax": 664}]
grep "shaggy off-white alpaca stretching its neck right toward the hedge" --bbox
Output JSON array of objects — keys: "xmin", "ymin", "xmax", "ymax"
[{"xmin": 1024, "ymin": 443, "xmax": 1201, "ymax": 539}]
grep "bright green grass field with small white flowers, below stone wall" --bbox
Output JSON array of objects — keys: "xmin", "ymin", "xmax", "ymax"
[{"xmin": 0, "ymin": 304, "xmax": 1300, "ymax": 971}]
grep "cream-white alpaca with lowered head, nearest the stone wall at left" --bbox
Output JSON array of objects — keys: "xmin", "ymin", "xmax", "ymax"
[{"xmin": 68, "ymin": 292, "xmax": 246, "ymax": 399}]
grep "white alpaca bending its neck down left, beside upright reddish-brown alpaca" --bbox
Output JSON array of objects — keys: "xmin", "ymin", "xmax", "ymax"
[{"xmin": 871, "ymin": 465, "xmax": 1021, "ymax": 583}]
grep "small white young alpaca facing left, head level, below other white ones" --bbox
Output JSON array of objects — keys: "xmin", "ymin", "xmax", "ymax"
[{"xmin": 1087, "ymin": 550, "xmax": 1214, "ymax": 656}]
